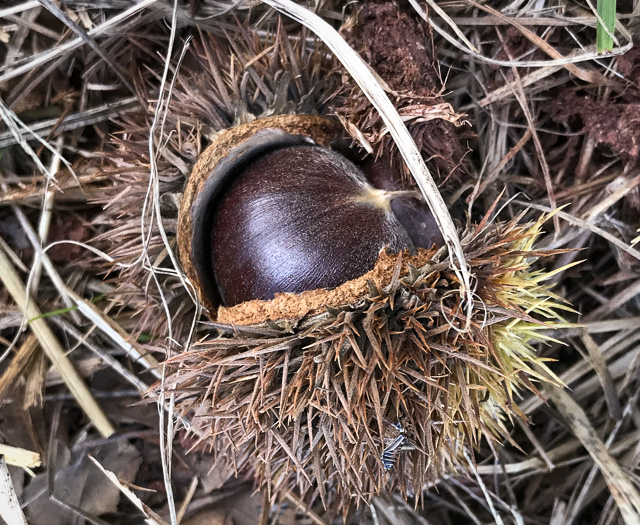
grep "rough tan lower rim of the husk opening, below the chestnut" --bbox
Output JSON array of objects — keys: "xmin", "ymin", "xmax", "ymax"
[{"xmin": 218, "ymin": 249, "xmax": 436, "ymax": 325}]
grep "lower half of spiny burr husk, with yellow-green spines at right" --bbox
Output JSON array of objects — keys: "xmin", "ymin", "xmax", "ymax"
[{"xmin": 165, "ymin": 212, "xmax": 568, "ymax": 510}]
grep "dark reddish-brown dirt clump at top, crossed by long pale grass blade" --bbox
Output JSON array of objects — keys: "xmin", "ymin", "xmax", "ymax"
[{"xmin": 337, "ymin": 0, "xmax": 469, "ymax": 184}]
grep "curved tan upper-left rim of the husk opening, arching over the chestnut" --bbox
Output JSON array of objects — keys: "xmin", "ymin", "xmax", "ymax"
[{"xmin": 178, "ymin": 115, "xmax": 340, "ymax": 320}]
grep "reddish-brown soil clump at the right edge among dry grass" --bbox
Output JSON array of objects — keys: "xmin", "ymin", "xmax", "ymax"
[{"xmin": 549, "ymin": 91, "xmax": 640, "ymax": 164}]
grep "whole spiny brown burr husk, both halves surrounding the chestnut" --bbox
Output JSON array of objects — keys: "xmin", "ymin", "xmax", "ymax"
[{"xmin": 92, "ymin": 17, "xmax": 566, "ymax": 509}]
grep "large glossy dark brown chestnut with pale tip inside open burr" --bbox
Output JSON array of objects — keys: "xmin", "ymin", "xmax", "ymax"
[{"xmin": 211, "ymin": 145, "xmax": 414, "ymax": 306}]
